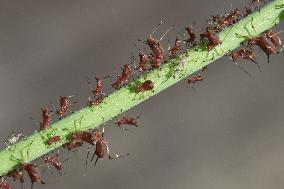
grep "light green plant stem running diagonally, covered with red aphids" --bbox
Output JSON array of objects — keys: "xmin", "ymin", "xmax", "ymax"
[{"xmin": 0, "ymin": 0, "xmax": 284, "ymax": 176}]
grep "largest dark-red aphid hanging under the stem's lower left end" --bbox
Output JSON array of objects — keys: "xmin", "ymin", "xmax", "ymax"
[{"xmin": 19, "ymin": 163, "xmax": 45, "ymax": 188}]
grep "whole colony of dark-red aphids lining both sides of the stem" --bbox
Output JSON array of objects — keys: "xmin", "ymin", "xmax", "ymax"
[{"xmin": 0, "ymin": 0, "xmax": 282, "ymax": 189}]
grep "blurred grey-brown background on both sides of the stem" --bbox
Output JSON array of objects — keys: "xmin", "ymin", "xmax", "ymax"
[{"xmin": 0, "ymin": 0, "xmax": 284, "ymax": 189}]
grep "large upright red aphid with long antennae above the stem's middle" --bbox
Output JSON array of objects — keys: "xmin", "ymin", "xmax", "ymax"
[{"xmin": 146, "ymin": 36, "xmax": 165, "ymax": 68}]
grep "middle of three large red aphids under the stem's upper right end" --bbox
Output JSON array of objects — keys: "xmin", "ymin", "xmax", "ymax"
[{"xmin": 248, "ymin": 36, "xmax": 277, "ymax": 63}]
